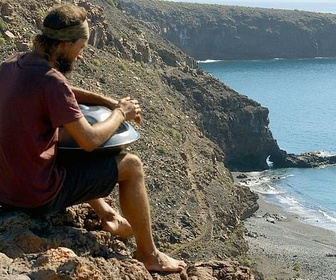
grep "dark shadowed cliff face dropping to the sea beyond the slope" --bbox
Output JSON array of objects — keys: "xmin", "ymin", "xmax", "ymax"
[{"xmin": 158, "ymin": 66, "xmax": 285, "ymax": 171}]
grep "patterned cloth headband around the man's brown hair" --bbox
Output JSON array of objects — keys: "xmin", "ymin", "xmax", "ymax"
[{"xmin": 42, "ymin": 20, "xmax": 89, "ymax": 41}]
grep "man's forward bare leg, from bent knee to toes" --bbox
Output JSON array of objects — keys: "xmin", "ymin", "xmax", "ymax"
[{"xmin": 117, "ymin": 154, "xmax": 186, "ymax": 272}]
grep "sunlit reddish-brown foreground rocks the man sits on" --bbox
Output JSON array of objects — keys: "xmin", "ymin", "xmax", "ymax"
[{"xmin": 0, "ymin": 207, "xmax": 254, "ymax": 280}]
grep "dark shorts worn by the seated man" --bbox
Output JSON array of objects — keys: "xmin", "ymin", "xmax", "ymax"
[{"xmin": 26, "ymin": 150, "xmax": 118, "ymax": 215}]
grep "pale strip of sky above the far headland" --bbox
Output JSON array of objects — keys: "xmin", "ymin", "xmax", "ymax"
[{"xmin": 166, "ymin": 0, "xmax": 336, "ymax": 14}]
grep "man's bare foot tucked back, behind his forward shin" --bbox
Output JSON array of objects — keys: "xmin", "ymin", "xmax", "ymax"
[{"xmin": 101, "ymin": 213, "xmax": 133, "ymax": 238}]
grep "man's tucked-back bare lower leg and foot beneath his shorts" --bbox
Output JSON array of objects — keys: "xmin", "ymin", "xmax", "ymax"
[{"xmin": 89, "ymin": 198, "xmax": 133, "ymax": 238}]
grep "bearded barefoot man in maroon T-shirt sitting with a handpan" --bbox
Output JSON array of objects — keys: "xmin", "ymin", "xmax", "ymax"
[{"xmin": 0, "ymin": 4, "xmax": 185, "ymax": 272}]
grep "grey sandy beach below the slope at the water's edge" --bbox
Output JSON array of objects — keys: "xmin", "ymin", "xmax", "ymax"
[{"xmin": 243, "ymin": 195, "xmax": 336, "ymax": 280}]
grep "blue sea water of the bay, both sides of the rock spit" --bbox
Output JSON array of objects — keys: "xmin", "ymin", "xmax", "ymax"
[{"xmin": 200, "ymin": 58, "xmax": 336, "ymax": 232}]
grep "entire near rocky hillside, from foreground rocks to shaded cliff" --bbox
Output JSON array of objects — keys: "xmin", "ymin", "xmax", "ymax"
[{"xmin": 0, "ymin": 0, "xmax": 280, "ymax": 279}]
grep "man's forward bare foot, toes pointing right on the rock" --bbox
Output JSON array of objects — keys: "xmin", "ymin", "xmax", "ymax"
[{"xmin": 135, "ymin": 250, "xmax": 187, "ymax": 272}]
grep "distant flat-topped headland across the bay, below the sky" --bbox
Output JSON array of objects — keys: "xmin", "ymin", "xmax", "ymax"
[{"xmin": 119, "ymin": 0, "xmax": 336, "ymax": 60}]
